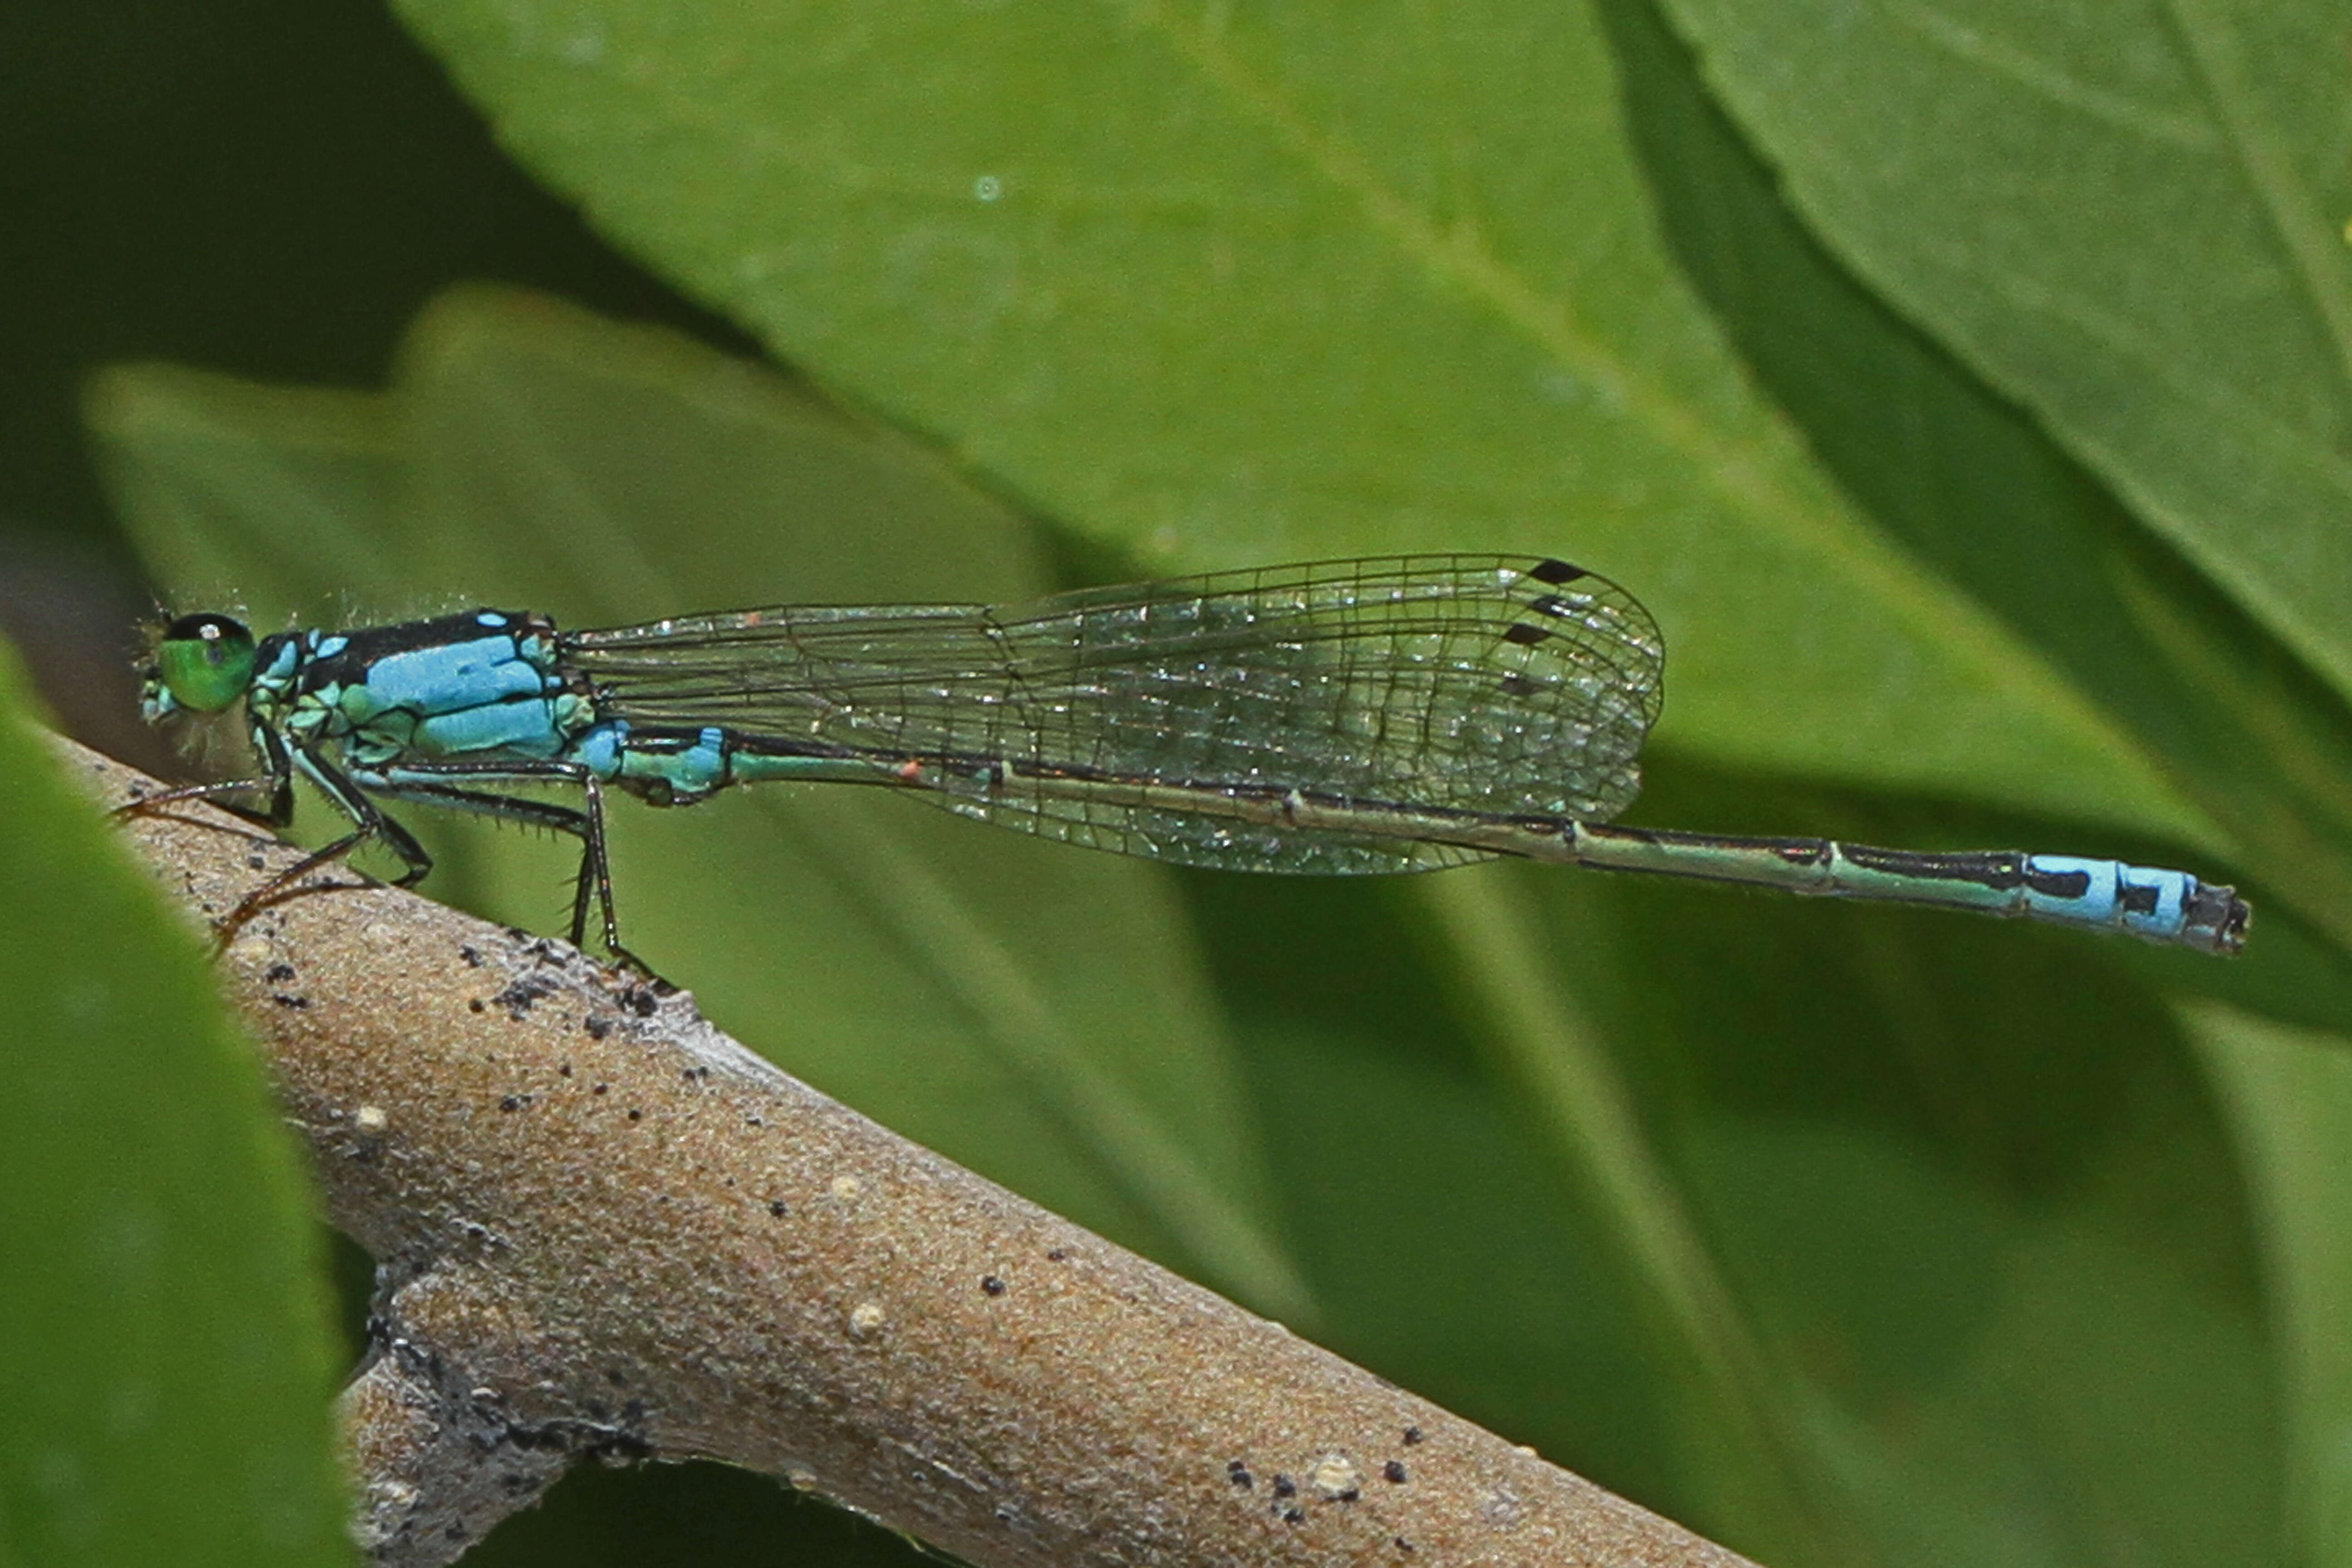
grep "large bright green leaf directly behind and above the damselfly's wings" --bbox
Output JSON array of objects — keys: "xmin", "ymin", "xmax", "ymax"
[{"xmin": 390, "ymin": 0, "xmax": 2218, "ymax": 860}]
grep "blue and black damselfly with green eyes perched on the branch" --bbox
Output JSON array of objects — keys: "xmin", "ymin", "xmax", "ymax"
[{"xmin": 132, "ymin": 555, "xmax": 2249, "ymax": 957}]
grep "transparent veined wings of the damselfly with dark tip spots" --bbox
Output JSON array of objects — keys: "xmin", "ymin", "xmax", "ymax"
[{"xmin": 564, "ymin": 555, "xmax": 1663, "ymax": 872}]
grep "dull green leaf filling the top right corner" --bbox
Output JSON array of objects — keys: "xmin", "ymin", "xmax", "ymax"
[{"xmin": 1670, "ymin": 0, "xmax": 2352, "ymax": 691}]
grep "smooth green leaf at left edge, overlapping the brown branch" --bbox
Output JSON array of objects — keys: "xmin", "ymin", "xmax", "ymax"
[{"xmin": 0, "ymin": 647, "xmax": 350, "ymax": 1568}]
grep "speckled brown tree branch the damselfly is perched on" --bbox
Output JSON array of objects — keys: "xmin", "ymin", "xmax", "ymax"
[{"xmin": 64, "ymin": 745, "xmax": 1745, "ymax": 1568}]
